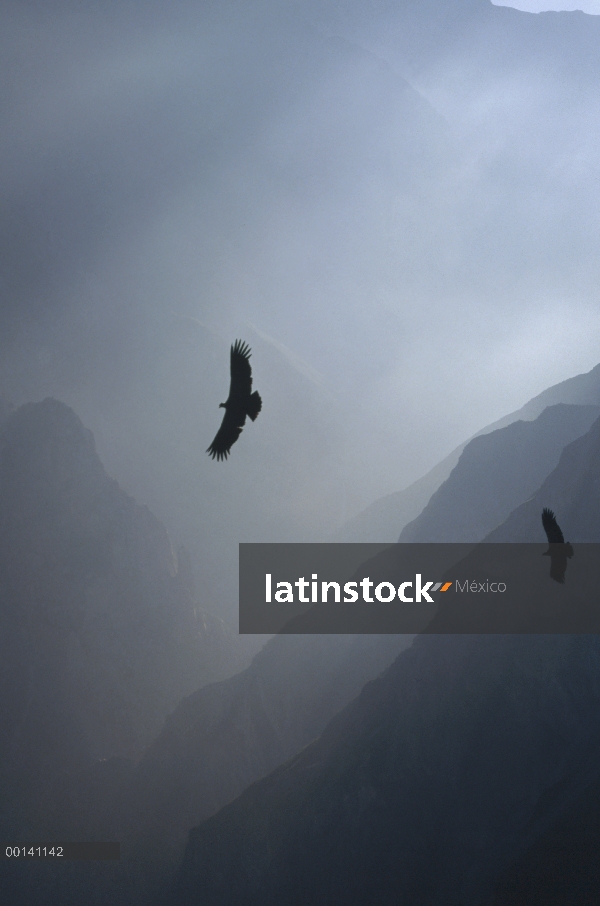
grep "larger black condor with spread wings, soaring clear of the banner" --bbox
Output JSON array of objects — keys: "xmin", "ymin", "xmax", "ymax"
[{"xmin": 206, "ymin": 340, "xmax": 262, "ymax": 460}]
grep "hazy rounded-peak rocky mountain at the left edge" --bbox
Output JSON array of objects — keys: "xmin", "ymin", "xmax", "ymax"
[{"xmin": 0, "ymin": 399, "xmax": 224, "ymax": 836}]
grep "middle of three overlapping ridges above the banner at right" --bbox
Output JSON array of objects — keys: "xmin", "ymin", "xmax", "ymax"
[{"xmin": 399, "ymin": 403, "xmax": 600, "ymax": 542}]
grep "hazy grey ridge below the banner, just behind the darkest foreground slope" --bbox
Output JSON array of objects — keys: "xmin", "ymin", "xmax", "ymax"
[{"xmin": 114, "ymin": 636, "xmax": 412, "ymax": 888}]
